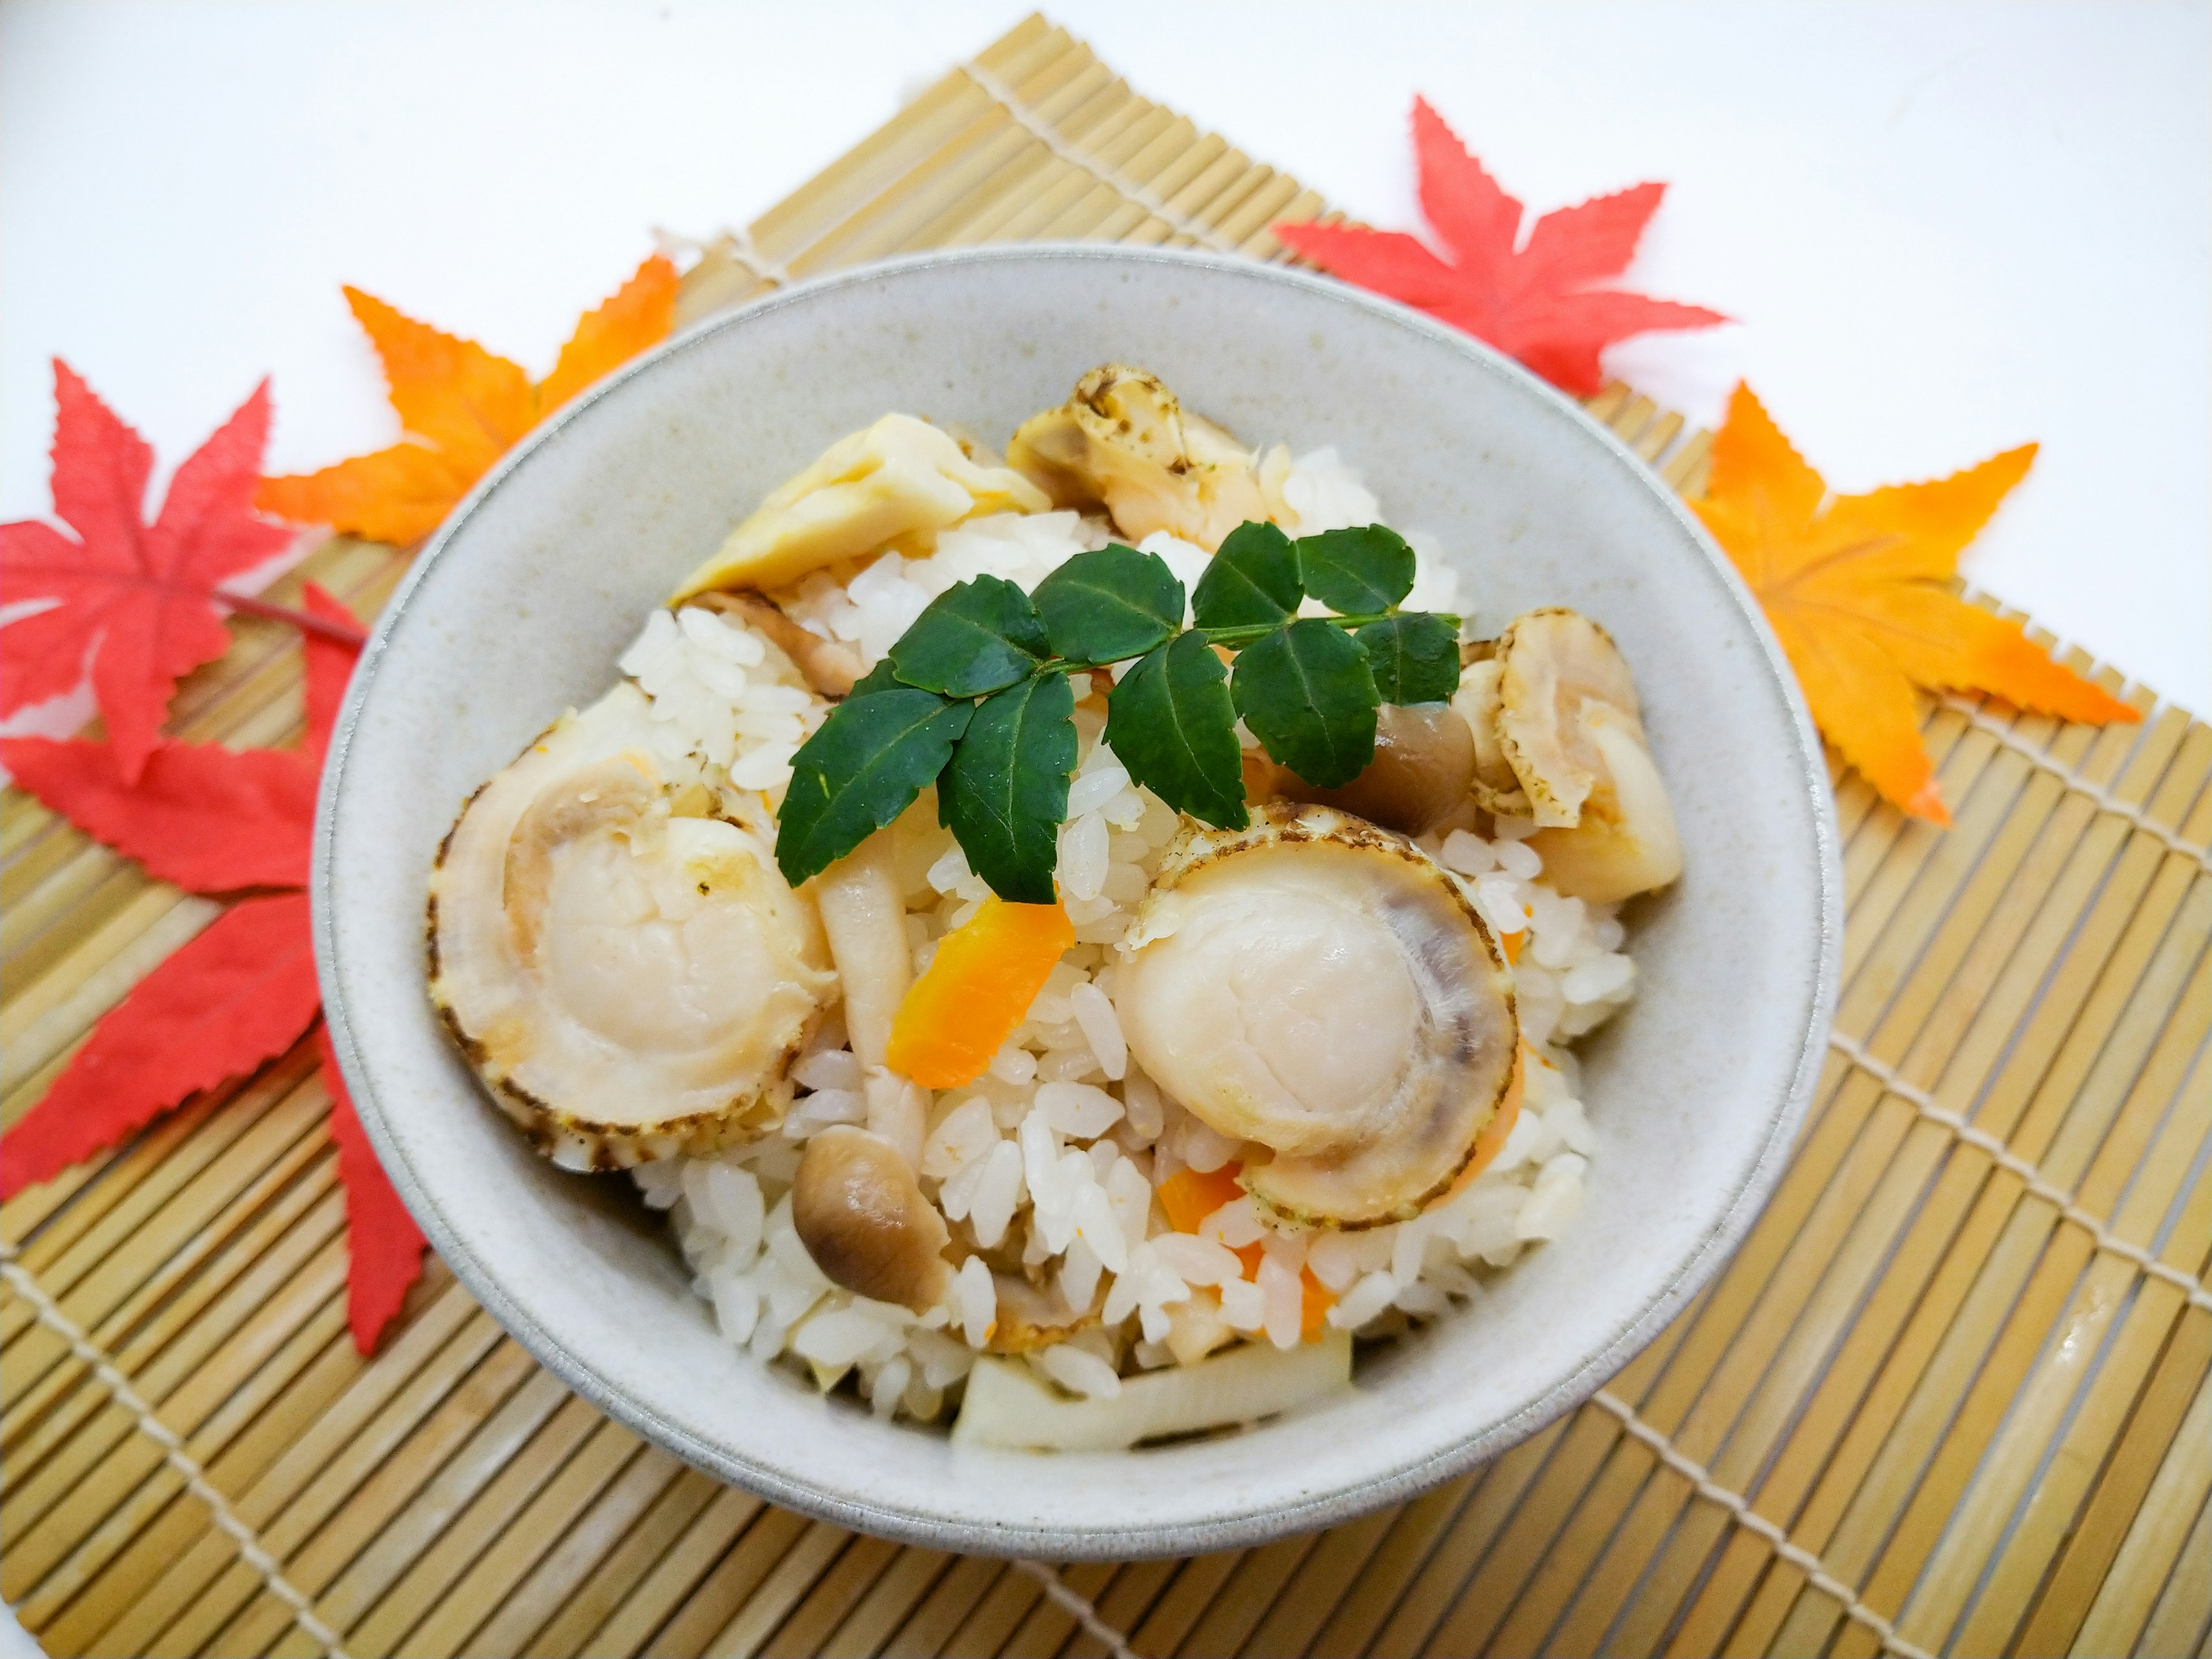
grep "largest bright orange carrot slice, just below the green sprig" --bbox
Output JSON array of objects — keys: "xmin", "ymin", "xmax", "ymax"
[{"xmin": 885, "ymin": 896, "xmax": 1075, "ymax": 1088}]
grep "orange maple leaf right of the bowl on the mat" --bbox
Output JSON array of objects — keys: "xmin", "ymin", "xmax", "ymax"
[{"xmin": 1692, "ymin": 385, "xmax": 2141, "ymax": 825}]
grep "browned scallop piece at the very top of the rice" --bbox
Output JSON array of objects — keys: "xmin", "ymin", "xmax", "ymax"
[{"xmin": 1006, "ymin": 363, "xmax": 1267, "ymax": 551}]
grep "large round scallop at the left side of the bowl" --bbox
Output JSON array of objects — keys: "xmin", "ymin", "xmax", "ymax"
[{"xmin": 429, "ymin": 684, "xmax": 836, "ymax": 1168}]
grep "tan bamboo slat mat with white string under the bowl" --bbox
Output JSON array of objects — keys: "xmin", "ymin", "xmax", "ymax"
[{"xmin": 0, "ymin": 18, "xmax": 2212, "ymax": 1654}]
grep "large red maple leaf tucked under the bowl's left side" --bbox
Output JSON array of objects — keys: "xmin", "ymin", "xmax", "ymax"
[{"xmin": 0, "ymin": 584, "xmax": 422, "ymax": 1354}]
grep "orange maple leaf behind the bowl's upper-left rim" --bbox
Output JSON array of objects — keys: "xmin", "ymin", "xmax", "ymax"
[{"xmin": 255, "ymin": 255, "xmax": 677, "ymax": 546}]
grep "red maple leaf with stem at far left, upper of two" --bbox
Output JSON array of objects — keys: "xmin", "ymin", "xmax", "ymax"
[{"xmin": 0, "ymin": 358, "xmax": 361, "ymax": 785}]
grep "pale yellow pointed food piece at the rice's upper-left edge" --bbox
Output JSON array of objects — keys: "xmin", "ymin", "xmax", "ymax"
[{"xmin": 675, "ymin": 414, "xmax": 1046, "ymax": 600}]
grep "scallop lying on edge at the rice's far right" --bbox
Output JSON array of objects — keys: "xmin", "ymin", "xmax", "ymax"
[{"xmin": 1451, "ymin": 611, "xmax": 1681, "ymax": 905}]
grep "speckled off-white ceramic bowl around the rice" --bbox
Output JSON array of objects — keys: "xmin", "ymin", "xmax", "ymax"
[{"xmin": 314, "ymin": 248, "xmax": 1843, "ymax": 1559}]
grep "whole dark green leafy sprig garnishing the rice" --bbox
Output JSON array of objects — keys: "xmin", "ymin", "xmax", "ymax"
[{"xmin": 777, "ymin": 520, "xmax": 1460, "ymax": 905}]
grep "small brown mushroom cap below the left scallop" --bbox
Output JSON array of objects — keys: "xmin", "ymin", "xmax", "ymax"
[{"xmin": 792, "ymin": 1124, "xmax": 951, "ymax": 1314}]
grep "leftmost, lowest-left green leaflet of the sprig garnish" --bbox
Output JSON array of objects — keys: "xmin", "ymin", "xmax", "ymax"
[{"xmin": 777, "ymin": 688, "xmax": 975, "ymax": 887}]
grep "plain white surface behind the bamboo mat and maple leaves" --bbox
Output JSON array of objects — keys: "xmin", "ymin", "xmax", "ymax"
[{"xmin": 0, "ymin": 0, "xmax": 2212, "ymax": 1646}]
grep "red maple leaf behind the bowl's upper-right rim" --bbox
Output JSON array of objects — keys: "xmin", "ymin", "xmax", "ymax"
[{"xmin": 1274, "ymin": 97, "xmax": 1728, "ymax": 396}]
